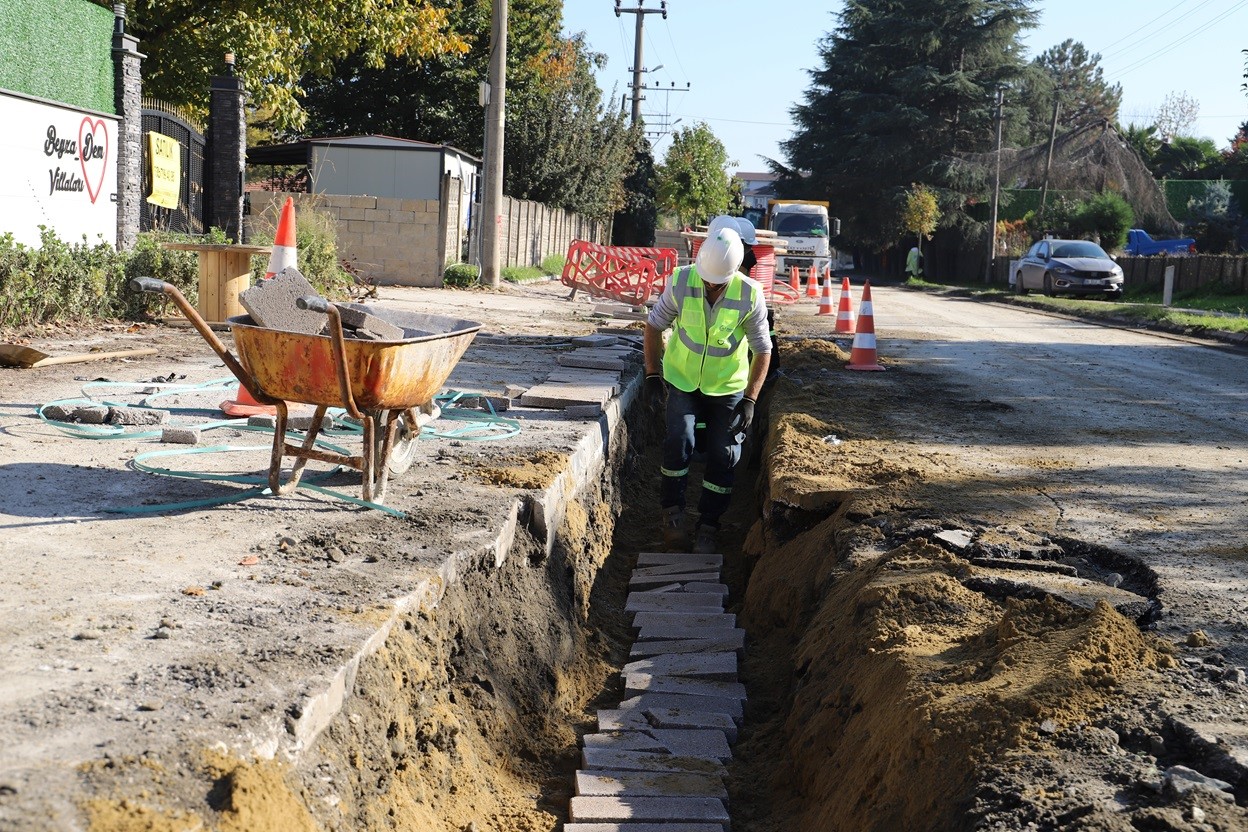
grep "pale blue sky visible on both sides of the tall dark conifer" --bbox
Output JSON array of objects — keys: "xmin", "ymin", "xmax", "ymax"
[{"xmin": 563, "ymin": 0, "xmax": 1248, "ymax": 171}]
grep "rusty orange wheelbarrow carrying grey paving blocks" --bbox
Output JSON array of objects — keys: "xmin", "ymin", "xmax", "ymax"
[{"xmin": 130, "ymin": 277, "xmax": 480, "ymax": 503}]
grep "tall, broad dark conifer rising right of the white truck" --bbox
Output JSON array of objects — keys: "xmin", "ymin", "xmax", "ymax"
[{"xmin": 773, "ymin": 0, "xmax": 1036, "ymax": 247}]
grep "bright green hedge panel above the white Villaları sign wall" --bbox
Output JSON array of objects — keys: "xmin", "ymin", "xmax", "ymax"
[{"xmin": 0, "ymin": 0, "xmax": 116, "ymax": 114}]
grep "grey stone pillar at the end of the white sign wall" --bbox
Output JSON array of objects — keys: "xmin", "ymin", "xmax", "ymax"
[{"xmin": 112, "ymin": 2, "xmax": 145, "ymax": 251}]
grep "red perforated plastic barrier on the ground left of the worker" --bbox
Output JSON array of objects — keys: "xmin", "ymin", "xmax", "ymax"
[{"xmin": 559, "ymin": 239, "xmax": 676, "ymax": 306}]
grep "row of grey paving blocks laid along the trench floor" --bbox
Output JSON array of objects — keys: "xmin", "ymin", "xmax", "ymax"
[{"xmin": 564, "ymin": 553, "xmax": 745, "ymax": 832}]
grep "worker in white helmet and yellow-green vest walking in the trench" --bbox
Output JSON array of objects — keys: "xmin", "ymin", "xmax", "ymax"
[{"xmin": 644, "ymin": 217, "xmax": 771, "ymax": 553}]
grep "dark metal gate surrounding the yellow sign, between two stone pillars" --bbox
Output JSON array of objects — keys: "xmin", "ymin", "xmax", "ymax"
[{"xmin": 139, "ymin": 99, "xmax": 205, "ymax": 235}]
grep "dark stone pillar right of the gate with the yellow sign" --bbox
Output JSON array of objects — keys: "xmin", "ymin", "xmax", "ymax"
[{"xmin": 203, "ymin": 54, "xmax": 247, "ymax": 243}]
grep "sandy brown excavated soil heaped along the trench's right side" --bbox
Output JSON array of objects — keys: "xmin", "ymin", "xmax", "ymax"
[{"xmin": 731, "ymin": 342, "xmax": 1248, "ymax": 832}]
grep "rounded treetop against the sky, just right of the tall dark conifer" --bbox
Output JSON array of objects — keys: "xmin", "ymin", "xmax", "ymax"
[{"xmin": 1018, "ymin": 39, "xmax": 1122, "ymax": 145}]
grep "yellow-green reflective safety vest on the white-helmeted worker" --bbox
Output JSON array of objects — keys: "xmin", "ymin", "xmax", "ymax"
[{"xmin": 663, "ymin": 266, "xmax": 759, "ymax": 395}]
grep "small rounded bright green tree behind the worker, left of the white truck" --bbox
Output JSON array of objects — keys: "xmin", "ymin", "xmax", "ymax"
[{"xmin": 658, "ymin": 121, "xmax": 736, "ymax": 225}]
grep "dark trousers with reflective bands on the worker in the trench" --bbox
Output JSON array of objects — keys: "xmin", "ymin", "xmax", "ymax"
[{"xmin": 659, "ymin": 384, "xmax": 743, "ymax": 526}]
